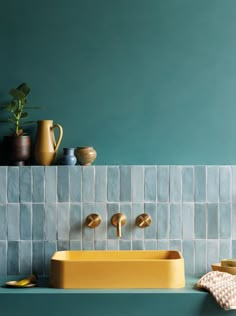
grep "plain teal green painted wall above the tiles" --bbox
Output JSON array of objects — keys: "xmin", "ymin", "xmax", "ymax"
[{"xmin": 0, "ymin": 0, "xmax": 236, "ymax": 164}]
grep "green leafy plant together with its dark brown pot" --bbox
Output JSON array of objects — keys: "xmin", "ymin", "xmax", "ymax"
[{"xmin": 0, "ymin": 83, "xmax": 36, "ymax": 166}]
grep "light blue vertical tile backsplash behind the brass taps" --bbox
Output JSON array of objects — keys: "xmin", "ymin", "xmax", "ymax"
[{"xmin": 0, "ymin": 166, "xmax": 236, "ymax": 276}]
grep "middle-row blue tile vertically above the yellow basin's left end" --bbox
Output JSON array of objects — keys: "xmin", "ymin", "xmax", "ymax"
[{"xmin": 45, "ymin": 203, "xmax": 57, "ymax": 240}]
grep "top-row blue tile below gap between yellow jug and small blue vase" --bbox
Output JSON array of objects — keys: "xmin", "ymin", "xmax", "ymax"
[{"xmin": 57, "ymin": 166, "xmax": 69, "ymax": 202}]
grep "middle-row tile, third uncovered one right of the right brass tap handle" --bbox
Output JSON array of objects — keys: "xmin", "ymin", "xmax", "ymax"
[{"xmin": 182, "ymin": 203, "xmax": 194, "ymax": 239}]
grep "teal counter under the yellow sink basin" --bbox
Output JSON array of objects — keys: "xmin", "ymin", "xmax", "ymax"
[{"xmin": 0, "ymin": 276, "xmax": 236, "ymax": 316}]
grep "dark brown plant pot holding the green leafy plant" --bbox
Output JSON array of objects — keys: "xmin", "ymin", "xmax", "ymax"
[{"xmin": 4, "ymin": 135, "xmax": 31, "ymax": 166}]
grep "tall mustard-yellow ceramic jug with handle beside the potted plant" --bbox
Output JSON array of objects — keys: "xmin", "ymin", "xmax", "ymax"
[{"xmin": 34, "ymin": 120, "xmax": 63, "ymax": 166}]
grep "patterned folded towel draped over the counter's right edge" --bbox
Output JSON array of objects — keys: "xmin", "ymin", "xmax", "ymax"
[{"xmin": 197, "ymin": 271, "xmax": 236, "ymax": 310}]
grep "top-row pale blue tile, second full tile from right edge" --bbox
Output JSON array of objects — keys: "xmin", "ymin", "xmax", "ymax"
[{"xmin": 207, "ymin": 166, "xmax": 219, "ymax": 203}]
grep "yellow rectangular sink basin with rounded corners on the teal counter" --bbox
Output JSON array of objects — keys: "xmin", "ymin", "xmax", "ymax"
[{"xmin": 50, "ymin": 250, "xmax": 185, "ymax": 289}]
